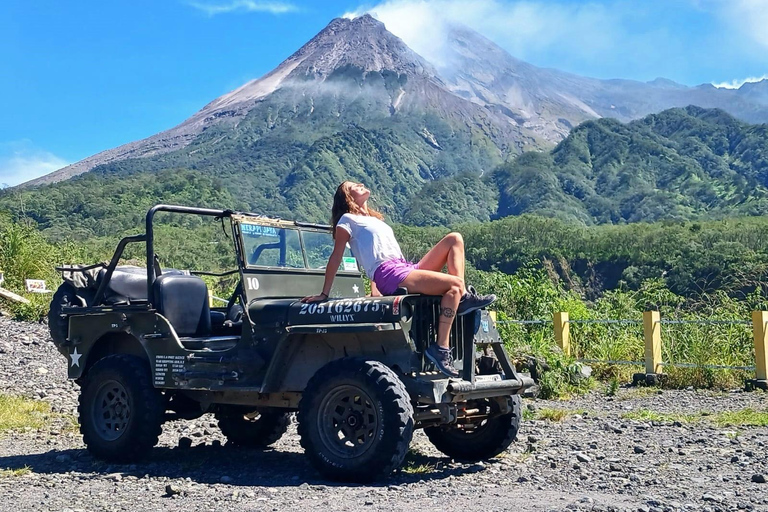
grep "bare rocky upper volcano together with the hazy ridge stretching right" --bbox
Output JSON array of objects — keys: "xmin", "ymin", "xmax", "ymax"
[{"xmin": 21, "ymin": 15, "xmax": 768, "ymax": 187}]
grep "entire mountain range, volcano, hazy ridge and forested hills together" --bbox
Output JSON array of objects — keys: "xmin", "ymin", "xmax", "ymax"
[{"xmin": 0, "ymin": 15, "xmax": 768, "ymax": 235}]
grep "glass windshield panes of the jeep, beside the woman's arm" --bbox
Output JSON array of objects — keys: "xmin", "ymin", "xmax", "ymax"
[{"xmin": 240, "ymin": 222, "xmax": 359, "ymax": 273}]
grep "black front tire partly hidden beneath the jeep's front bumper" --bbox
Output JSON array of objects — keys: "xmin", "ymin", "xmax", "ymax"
[{"xmin": 424, "ymin": 395, "xmax": 522, "ymax": 461}]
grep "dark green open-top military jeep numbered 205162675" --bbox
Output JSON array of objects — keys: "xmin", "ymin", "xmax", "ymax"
[{"xmin": 49, "ymin": 205, "xmax": 533, "ymax": 481}]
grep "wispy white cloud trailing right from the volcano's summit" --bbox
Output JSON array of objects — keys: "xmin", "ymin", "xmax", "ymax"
[{"xmin": 345, "ymin": 0, "xmax": 658, "ymax": 73}]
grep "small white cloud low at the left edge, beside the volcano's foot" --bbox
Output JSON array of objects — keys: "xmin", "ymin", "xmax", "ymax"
[{"xmin": 0, "ymin": 140, "xmax": 69, "ymax": 186}]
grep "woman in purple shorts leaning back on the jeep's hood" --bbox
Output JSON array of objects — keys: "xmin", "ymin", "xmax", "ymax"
[{"xmin": 302, "ymin": 181, "xmax": 496, "ymax": 377}]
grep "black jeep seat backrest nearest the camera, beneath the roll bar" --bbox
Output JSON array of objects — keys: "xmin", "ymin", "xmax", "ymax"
[{"xmin": 152, "ymin": 274, "xmax": 211, "ymax": 337}]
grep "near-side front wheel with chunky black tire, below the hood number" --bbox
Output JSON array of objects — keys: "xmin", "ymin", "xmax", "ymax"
[{"xmin": 298, "ymin": 358, "xmax": 413, "ymax": 482}]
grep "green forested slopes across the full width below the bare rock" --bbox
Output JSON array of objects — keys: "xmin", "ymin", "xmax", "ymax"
[{"xmin": 0, "ymin": 107, "xmax": 768, "ymax": 238}]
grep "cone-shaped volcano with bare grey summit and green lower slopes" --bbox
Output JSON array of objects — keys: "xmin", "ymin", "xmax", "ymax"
[{"xmin": 22, "ymin": 16, "xmax": 536, "ymax": 218}]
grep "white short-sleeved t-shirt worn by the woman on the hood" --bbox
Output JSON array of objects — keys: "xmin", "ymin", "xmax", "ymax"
[{"xmin": 336, "ymin": 213, "xmax": 403, "ymax": 278}]
